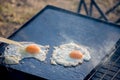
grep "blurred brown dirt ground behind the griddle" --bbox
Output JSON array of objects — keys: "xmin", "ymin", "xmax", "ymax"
[{"xmin": 0, "ymin": 0, "xmax": 120, "ymax": 37}]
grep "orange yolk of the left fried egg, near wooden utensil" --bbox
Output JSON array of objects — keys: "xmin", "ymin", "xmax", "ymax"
[{"xmin": 25, "ymin": 44, "xmax": 40, "ymax": 54}]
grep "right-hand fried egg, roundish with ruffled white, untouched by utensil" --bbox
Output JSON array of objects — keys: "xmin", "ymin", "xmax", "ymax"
[{"xmin": 51, "ymin": 42, "xmax": 91, "ymax": 66}]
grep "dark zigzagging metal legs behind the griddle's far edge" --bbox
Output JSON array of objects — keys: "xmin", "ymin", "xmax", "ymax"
[{"xmin": 77, "ymin": 0, "xmax": 120, "ymax": 23}]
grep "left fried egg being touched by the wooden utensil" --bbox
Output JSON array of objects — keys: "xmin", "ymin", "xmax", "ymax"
[{"xmin": 4, "ymin": 42, "xmax": 49, "ymax": 64}]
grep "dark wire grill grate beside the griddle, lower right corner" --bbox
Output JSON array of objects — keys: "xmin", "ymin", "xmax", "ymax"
[{"xmin": 84, "ymin": 39, "xmax": 120, "ymax": 80}]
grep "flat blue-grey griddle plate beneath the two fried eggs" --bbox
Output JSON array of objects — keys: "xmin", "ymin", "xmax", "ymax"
[{"xmin": 0, "ymin": 6, "xmax": 120, "ymax": 80}]
